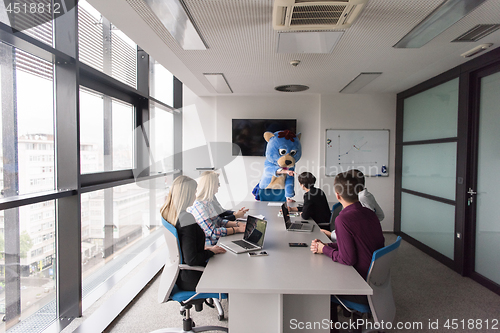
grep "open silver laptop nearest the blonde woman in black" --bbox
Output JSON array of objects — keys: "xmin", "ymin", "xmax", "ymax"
[{"xmin": 217, "ymin": 215, "xmax": 267, "ymax": 254}]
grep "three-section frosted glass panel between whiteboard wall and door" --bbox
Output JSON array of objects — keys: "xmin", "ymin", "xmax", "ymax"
[{"xmin": 401, "ymin": 78, "xmax": 458, "ymax": 260}]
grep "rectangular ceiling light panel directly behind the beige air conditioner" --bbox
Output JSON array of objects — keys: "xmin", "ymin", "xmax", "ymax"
[{"xmin": 277, "ymin": 31, "xmax": 344, "ymax": 53}]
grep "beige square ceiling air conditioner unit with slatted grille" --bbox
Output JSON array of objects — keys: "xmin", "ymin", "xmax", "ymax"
[{"xmin": 273, "ymin": 0, "xmax": 368, "ymax": 31}]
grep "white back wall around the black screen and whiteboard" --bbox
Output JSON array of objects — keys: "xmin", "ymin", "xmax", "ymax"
[{"xmin": 183, "ymin": 88, "xmax": 396, "ymax": 231}]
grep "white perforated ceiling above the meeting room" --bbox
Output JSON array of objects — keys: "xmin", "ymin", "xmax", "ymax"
[{"xmin": 88, "ymin": 0, "xmax": 500, "ymax": 96}]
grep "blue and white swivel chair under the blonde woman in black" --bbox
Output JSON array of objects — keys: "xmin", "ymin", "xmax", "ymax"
[{"xmin": 151, "ymin": 218, "xmax": 228, "ymax": 333}]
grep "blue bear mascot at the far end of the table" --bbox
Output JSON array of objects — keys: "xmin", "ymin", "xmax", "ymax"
[{"xmin": 252, "ymin": 130, "xmax": 302, "ymax": 201}]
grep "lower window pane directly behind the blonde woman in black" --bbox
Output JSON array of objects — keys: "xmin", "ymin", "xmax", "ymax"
[{"xmin": 81, "ymin": 177, "xmax": 167, "ymax": 298}]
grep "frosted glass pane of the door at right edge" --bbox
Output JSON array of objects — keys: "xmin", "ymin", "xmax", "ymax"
[{"xmin": 473, "ymin": 72, "xmax": 500, "ymax": 284}]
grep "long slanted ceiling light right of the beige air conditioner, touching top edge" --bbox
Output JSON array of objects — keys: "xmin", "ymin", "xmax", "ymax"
[{"xmin": 393, "ymin": 0, "xmax": 486, "ymax": 48}]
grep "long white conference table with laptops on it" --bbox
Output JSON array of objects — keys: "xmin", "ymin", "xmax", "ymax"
[{"xmin": 196, "ymin": 201, "xmax": 373, "ymax": 333}]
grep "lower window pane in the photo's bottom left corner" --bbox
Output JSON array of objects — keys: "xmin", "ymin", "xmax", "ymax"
[{"xmin": 0, "ymin": 201, "xmax": 56, "ymax": 332}]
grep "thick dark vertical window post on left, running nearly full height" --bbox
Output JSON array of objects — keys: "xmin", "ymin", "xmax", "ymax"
[{"xmin": 54, "ymin": 0, "xmax": 82, "ymax": 318}]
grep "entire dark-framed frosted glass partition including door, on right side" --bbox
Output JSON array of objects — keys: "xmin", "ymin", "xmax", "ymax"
[{"xmin": 395, "ymin": 49, "xmax": 500, "ymax": 294}]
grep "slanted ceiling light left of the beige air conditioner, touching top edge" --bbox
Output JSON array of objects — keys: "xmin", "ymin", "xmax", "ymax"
[{"xmin": 144, "ymin": 0, "xmax": 208, "ymax": 50}]
